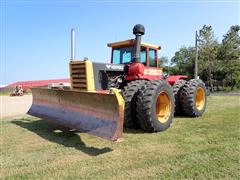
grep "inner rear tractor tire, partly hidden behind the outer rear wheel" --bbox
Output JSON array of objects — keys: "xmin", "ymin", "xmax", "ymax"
[{"xmin": 172, "ymin": 79, "xmax": 187, "ymax": 115}]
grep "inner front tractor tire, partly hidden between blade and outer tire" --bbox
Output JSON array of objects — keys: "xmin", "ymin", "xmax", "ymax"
[{"xmin": 122, "ymin": 80, "xmax": 147, "ymax": 128}]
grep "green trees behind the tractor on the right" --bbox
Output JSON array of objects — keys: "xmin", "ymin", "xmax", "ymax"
[{"xmin": 159, "ymin": 25, "xmax": 240, "ymax": 92}]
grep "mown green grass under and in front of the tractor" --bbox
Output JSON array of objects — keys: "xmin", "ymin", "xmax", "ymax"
[{"xmin": 0, "ymin": 96, "xmax": 240, "ymax": 179}]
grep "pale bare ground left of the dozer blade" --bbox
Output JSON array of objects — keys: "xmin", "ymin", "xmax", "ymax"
[{"xmin": 0, "ymin": 95, "xmax": 32, "ymax": 118}]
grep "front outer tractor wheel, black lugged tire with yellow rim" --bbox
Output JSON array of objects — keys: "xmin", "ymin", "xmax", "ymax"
[{"xmin": 137, "ymin": 80, "xmax": 174, "ymax": 132}]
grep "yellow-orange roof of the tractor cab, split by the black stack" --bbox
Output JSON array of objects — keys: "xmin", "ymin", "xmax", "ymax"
[{"xmin": 107, "ymin": 39, "xmax": 161, "ymax": 49}]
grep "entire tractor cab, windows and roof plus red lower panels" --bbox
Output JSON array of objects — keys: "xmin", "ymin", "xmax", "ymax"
[{"xmin": 108, "ymin": 39, "xmax": 163, "ymax": 81}]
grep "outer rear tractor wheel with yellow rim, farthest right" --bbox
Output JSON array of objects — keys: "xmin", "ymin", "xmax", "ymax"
[{"xmin": 180, "ymin": 79, "xmax": 207, "ymax": 117}]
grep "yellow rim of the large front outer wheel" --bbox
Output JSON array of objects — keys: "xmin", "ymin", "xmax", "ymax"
[{"xmin": 156, "ymin": 91, "xmax": 171, "ymax": 123}]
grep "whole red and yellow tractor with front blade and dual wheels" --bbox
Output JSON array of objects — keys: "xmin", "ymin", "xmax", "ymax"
[{"xmin": 28, "ymin": 24, "xmax": 207, "ymax": 140}]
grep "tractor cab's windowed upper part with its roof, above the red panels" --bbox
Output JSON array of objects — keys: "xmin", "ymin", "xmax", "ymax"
[{"xmin": 108, "ymin": 39, "xmax": 161, "ymax": 68}]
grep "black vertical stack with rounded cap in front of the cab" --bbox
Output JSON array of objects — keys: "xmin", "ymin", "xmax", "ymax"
[{"xmin": 133, "ymin": 24, "xmax": 145, "ymax": 62}]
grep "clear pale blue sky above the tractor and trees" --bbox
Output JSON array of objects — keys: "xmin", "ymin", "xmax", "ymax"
[{"xmin": 0, "ymin": 0, "xmax": 240, "ymax": 85}]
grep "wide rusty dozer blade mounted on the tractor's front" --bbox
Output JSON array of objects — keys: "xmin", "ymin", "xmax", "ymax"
[{"xmin": 27, "ymin": 88, "xmax": 124, "ymax": 141}]
